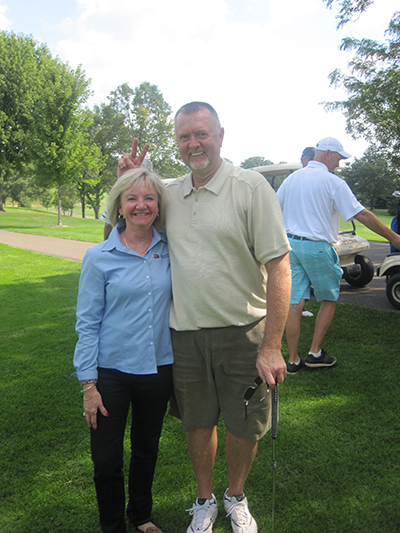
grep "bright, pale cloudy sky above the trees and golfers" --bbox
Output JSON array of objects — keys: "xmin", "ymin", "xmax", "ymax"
[{"xmin": 0, "ymin": 0, "xmax": 399, "ymax": 165}]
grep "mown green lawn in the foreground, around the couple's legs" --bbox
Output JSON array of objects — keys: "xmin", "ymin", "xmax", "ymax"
[{"xmin": 0, "ymin": 243, "xmax": 400, "ymax": 533}]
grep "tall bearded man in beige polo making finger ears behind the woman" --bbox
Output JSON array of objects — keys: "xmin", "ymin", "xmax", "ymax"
[{"xmin": 115, "ymin": 102, "xmax": 290, "ymax": 533}]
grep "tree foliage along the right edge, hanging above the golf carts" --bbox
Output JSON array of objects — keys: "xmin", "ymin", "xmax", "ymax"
[{"xmin": 322, "ymin": 0, "xmax": 400, "ymax": 215}]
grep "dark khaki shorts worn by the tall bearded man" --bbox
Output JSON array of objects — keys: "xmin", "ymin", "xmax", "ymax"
[{"xmin": 171, "ymin": 319, "xmax": 271, "ymax": 441}]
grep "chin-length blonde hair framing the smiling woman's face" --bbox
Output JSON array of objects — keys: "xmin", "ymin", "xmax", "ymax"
[{"xmin": 107, "ymin": 167, "xmax": 167, "ymax": 230}]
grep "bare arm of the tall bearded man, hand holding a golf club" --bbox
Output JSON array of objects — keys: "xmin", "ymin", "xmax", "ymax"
[{"xmin": 257, "ymin": 253, "xmax": 292, "ymax": 387}]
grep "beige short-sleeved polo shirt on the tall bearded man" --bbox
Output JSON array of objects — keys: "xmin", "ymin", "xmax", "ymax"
[{"xmin": 166, "ymin": 161, "xmax": 290, "ymax": 330}]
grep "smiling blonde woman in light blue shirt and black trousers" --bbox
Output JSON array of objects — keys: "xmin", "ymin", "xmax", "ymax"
[{"xmin": 74, "ymin": 168, "xmax": 173, "ymax": 533}]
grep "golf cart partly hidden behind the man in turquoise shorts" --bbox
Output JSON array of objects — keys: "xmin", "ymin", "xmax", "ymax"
[{"xmin": 252, "ymin": 163, "xmax": 376, "ymax": 290}]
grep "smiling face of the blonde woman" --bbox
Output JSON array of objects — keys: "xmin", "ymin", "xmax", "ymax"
[{"xmin": 119, "ymin": 181, "xmax": 159, "ymax": 229}]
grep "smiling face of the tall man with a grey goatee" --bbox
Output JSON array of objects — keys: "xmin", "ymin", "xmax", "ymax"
[{"xmin": 175, "ymin": 109, "xmax": 224, "ymax": 174}]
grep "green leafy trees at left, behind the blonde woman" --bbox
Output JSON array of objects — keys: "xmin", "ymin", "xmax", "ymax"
[{"xmin": 0, "ymin": 31, "xmax": 185, "ymax": 225}]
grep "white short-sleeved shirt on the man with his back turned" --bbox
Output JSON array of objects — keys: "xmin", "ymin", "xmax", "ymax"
[{"xmin": 278, "ymin": 161, "xmax": 364, "ymax": 243}]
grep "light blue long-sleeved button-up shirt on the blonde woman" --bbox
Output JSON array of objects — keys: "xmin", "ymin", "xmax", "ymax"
[{"xmin": 74, "ymin": 223, "xmax": 173, "ymax": 380}]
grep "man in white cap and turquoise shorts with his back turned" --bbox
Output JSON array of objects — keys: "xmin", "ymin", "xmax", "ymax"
[{"xmin": 278, "ymin": 137, "xmax": 400, "ymax": 374}]
